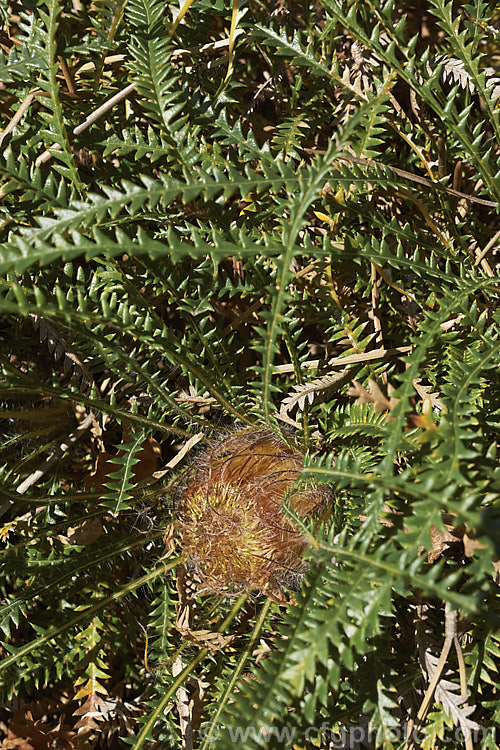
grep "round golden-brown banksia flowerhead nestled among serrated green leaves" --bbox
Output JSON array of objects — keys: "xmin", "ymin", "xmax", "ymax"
[{"xmin": 178, "ymin": 428, "xmax": 328, "ymax": 596}]
